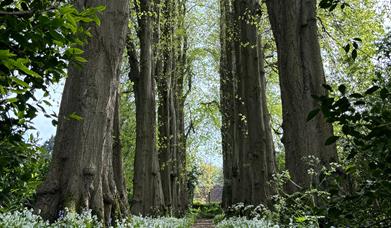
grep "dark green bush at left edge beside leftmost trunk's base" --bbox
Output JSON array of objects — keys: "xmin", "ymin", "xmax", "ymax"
[{"xmin": 0, "ymin": 135, "xmax": 50, "ymax": 211}]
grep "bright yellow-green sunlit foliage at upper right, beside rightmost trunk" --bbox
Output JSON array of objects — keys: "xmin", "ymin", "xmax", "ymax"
[{"xmin": 318, "ymin": 0, "xmax": 385, "ymax": 90}]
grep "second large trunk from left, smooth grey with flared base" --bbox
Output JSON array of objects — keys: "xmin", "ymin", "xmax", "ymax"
[{"xmin": 131, "ymin": 0, "xmax": 164, "ymax": 215}]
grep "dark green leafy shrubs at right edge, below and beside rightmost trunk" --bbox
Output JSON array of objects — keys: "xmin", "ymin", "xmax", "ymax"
[{"xmin": 310, "ymin": 78, "xmax": 391, "ymax": 226}]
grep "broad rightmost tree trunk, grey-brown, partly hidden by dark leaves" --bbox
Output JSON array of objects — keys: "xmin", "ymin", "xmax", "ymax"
[{"xmin": 266, "ymin": 0, "xmax": 337, "ymax": 192}]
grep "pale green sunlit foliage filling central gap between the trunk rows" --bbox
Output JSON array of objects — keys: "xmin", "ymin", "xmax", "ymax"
[{"xmin": 185, "ymin": 0, "xmax": 221, "ymax": 160}]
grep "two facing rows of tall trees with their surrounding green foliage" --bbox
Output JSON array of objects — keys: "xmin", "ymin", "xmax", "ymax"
[{"xmin": 0, "ymin": 0, "xmax": 391, "ymax": 226}]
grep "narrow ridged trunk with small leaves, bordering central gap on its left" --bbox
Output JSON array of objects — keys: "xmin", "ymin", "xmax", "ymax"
[{"xmin": 157, "ymin": 0, "xmax": 187, "ymax": 215}]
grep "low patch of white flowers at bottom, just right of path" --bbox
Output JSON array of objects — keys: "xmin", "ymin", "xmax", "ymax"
[{"xmin": 216, "ymin": 217, "xmax": 279, "ymax": 228}]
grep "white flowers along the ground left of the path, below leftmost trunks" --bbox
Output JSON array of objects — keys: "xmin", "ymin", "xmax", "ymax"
[{"xmin": 0, "ymin": 209, "xmax": 193, "ymax": 228}]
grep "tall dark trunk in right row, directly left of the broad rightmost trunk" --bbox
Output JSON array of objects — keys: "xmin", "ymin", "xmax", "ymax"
[{"xmin": 240, "ymin": 0, "xmax": 267, "ymax": 204}]
